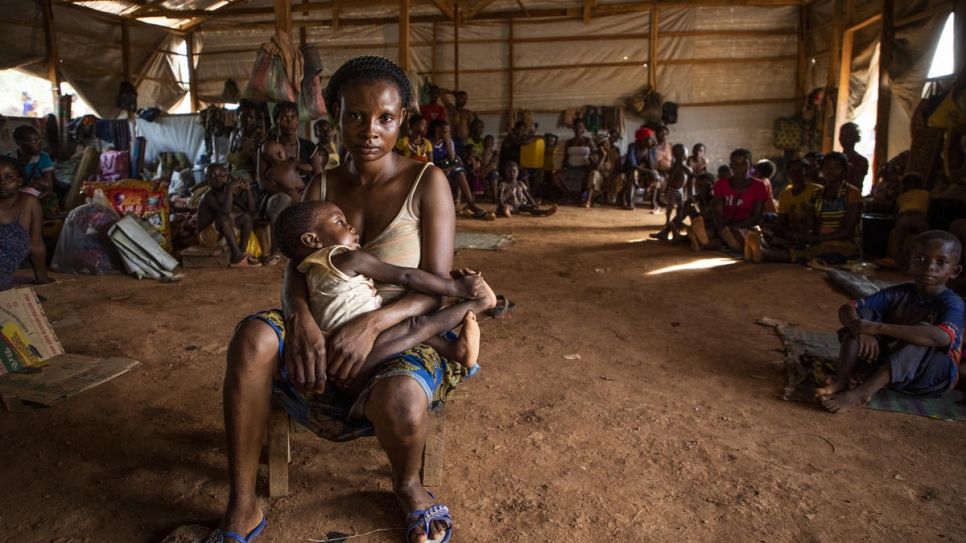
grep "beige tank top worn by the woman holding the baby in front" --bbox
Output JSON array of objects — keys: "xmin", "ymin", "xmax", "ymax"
[{"xmin": 319, "ymin": 163, "xmax": 431, "ymax": 304}]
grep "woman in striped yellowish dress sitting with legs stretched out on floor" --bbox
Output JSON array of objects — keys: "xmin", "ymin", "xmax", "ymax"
[{"xmin": 747, "ymin": 153, "xmax": 862, "ymax": 267}]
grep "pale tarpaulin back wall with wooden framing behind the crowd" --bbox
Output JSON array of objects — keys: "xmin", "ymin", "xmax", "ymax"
[{"xmin": 196, "ymin": 7, "xmax": 799, "ymax": 166}]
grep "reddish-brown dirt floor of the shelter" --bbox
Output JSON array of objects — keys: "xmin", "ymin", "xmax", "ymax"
[{"xmin": 0, "ymin": 207, "xmax": 966, "ymax": 543}]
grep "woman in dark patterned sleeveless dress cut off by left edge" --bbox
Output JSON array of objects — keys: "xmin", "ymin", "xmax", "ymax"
[{"xmin": 0, "ymin": 155, "xmax": 54, "ymax": 290}]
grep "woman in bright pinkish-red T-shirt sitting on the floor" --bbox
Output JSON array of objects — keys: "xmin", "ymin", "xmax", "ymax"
[{"xmin": 688, "ymin": 149, "xmax": 768, "ymax": 253}]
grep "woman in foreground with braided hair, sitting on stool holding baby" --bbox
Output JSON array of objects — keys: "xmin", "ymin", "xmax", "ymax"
[{"xmin": 212, "ymin": 56, "xmax": 468, "ymax": 542}]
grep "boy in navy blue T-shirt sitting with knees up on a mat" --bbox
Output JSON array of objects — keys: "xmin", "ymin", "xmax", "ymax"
[{"xmin": 815, "ymin": 230, "xmax": 966, "ymax": 413}]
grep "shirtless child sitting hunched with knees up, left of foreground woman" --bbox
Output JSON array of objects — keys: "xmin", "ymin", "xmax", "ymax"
[{"xmin": 198, "ymin": 164, "xmax": 260, "ymax": 268}]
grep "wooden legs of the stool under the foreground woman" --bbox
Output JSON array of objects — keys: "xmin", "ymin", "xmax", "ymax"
[{"xmin": 268, "ymin": 404, "xmax": 446, "ymax": 498}]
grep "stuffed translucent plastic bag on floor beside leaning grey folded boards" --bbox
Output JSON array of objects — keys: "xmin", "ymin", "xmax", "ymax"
[{"xmin": 50, "ymin": 190, "xmax": 124, "ymax": 275}]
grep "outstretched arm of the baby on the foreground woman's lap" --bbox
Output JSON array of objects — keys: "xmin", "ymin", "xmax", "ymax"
[{"xmin": 332, "ymin": 251, "xmax": 486, "ymax": 300}]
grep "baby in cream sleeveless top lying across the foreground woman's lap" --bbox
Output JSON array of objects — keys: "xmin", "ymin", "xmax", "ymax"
[{"xmin": 275, "ymin": 201, "xmax": 496, "ymax": 390}]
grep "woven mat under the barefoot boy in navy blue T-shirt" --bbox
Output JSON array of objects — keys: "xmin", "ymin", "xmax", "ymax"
[{"xmin": 775, "ymin": 325, "xmax": 966, "ymax": 421}]
